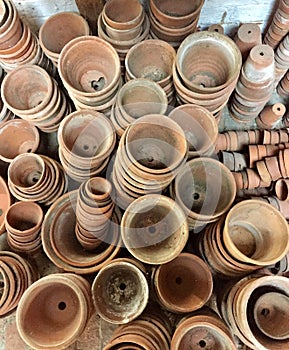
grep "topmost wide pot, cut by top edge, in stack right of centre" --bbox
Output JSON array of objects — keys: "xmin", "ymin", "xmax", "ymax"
[{"xmin": 150, "ymin": 0, "xmax": 204, "ymax": 28}]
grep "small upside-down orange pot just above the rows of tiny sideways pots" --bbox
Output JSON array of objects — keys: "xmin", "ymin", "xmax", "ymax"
[{"xmin": 256, "ymin": 103, "xmax": 286, "ymax": 129}]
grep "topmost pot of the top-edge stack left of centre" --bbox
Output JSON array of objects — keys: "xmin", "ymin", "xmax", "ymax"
[{"xmin": 103, "ymin": 0, "xmax": 143, "ymax": 29}]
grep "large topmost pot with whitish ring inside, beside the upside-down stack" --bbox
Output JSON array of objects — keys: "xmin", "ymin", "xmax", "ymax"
[{"xmin": 176, "ymin": 31, "xmax": 241, "ymax": 93}]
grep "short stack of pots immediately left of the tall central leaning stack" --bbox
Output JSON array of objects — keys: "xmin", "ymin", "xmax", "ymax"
[{"xmin": 58, "ymin": 110, "xmax": 116, "ymax": 182}]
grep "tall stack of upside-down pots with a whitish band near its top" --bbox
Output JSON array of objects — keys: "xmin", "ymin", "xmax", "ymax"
[{"xmin": 230, "ymin": 45, "xmax": 275, "ymax": 123}]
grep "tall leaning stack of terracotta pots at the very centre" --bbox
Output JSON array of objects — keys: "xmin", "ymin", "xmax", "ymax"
[{"xmin": 111, "ymin": 114, "xmax": 187, "ymax": 208}]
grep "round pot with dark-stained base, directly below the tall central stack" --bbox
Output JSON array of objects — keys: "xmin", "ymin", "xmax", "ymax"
[{"xmin": 121, "ymin": 194, "xmax": 188, "ymax": 264}]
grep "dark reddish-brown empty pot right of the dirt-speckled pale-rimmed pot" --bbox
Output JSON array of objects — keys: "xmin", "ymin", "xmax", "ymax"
[{"xmin": 153, "ymin": 253, "xmax": 213, "ymax": 313}]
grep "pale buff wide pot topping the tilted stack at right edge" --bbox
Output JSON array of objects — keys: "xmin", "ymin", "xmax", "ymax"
[{"xmin": 223, "ymin": 200, "xmax": 289, "ymax": 267}]
